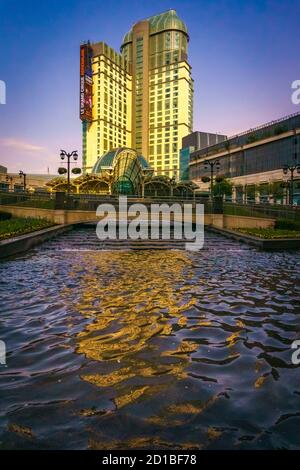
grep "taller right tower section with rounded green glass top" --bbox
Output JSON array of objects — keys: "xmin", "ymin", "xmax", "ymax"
[{"xmin": 121, "ymin": 10, "xmax": 193, "ymax": 176}]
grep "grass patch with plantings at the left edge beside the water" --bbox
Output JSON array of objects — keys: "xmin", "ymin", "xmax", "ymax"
[{"xmin": 0, "ymin": 217, "xmax": 54, "ymax": 240}]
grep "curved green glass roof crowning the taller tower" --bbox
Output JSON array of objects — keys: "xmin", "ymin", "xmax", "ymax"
[{"xmin": 123, "ymin": 10, "xmax": 188, "ymax": 45}]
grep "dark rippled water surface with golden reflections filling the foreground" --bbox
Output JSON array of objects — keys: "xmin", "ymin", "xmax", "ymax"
[{"xmin": 0, "ymin": 228, "xmax": 300, "ymax": 449}]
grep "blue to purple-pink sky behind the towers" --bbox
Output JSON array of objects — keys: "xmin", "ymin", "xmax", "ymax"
[{"xmin": 0, "ymin": 0, "xmax": 300, "ymax": 173}]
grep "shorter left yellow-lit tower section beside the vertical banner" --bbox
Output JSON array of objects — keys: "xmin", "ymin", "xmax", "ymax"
[{"xmin": 82, "ymin": 42, "xmax": 132, "ymax": 172}]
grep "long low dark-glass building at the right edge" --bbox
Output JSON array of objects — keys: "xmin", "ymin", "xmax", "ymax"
[{"xmin": 190, "ymin": 113, "xmax": 300, "ymax": 203}]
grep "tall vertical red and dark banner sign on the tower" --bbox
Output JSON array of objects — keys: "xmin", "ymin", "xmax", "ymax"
[{"xmin": 80, "ymin": 44, "xmax": 93, "ymax": 121}]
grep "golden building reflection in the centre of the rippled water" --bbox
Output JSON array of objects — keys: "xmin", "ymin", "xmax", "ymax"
[{"xmin": 65, "ymin": 251, "xmax": 198, "ymax": 408}]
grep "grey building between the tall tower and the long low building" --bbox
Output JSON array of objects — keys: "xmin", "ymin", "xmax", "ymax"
[{"xmin": 180, "ymin": 131, "xmax": 227, "ymax": 181}]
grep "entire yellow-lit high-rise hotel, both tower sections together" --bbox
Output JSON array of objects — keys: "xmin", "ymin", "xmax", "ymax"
[{"xmin": 80, "ymin": 10, "xmax": 193, "ymax": 178}]
